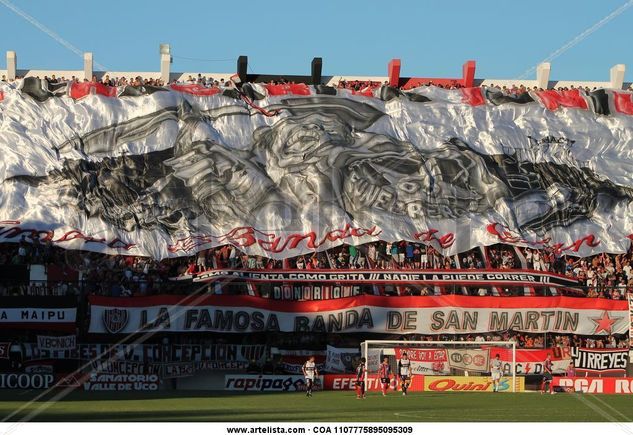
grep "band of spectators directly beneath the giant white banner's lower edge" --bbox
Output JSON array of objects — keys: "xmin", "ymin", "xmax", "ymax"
[{"xmin": 0, "ymin": 236, "xmax": 633, "ymax": 299}]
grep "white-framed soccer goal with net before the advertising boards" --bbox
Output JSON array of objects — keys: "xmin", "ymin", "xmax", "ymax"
[{"xmin": 360, "ymin": 340, "xmax": 523, "ymax": 392}]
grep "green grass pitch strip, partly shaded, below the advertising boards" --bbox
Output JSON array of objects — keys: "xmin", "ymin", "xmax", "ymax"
[{"xmin": 0, "ymin": 390, "xmax": 633, "ymax": 422}]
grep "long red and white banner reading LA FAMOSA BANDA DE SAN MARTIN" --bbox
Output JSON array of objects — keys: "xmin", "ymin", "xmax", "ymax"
[{"xmin": 89, "ymin": 294, "xmax": 629, "ymax": 335}]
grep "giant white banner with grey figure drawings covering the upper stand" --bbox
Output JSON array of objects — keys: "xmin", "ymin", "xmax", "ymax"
[{"xmin": 0, "ymin": 82, "xmax": 633, "ymax": 258}]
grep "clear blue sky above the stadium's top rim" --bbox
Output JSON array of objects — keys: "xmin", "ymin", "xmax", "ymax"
[{"xmin": 0, "ymin": 0, "xmax": 633, "ymax": 81}]
